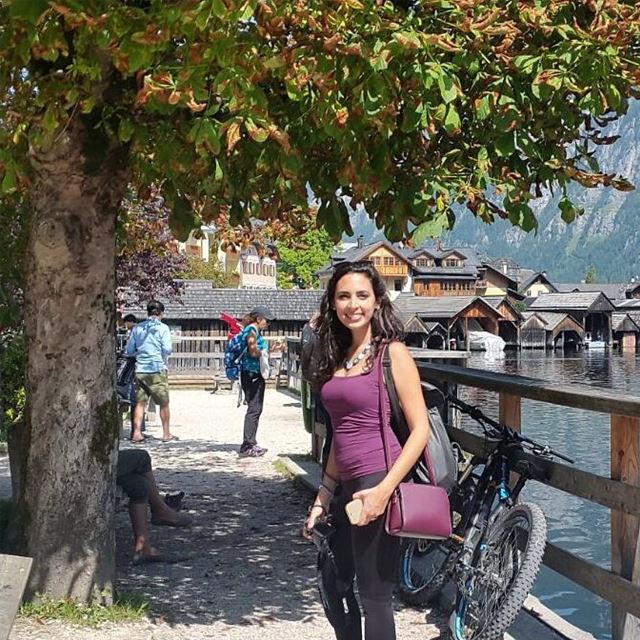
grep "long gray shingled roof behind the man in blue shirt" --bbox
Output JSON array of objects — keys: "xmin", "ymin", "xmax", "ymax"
[{"xmin": 125, "ymin": 280, "xmax": 324, "ymax": 321}]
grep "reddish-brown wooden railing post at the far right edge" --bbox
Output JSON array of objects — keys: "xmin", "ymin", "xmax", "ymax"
[{"xmin": 611, "ymin": 415, "xmax": 640, "ymax": 640}]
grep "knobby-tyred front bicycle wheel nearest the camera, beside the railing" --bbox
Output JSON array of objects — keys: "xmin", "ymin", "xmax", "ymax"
[{"xmin": 451, "ymin": 503, "xmax": 547, "ymax": 640}]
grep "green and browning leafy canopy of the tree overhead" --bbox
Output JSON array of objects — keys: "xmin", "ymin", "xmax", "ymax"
[{"xmin": 0, "ymin": 0, "xmax": 640, "ymax": 239}]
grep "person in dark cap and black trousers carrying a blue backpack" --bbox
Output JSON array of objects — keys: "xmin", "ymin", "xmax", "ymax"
[{"xmin": 238, "ymin": 307, "xmax": 275, "ymax": 458}]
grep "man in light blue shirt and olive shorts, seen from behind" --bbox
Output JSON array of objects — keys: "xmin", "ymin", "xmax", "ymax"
[{"xmin": 127, "ymin": 300, "xmax": 178, "ymax": 442}]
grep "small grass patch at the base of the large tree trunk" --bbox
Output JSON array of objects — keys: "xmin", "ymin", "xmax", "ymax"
[{"xmin": 20, "ymin": 593, "xmax": 149, "ymax": 627}]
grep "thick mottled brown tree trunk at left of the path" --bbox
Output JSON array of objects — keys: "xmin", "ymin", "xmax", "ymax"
[{"xmin": 19, "ymin": 118, "xmax": 127, "ymax": 603}]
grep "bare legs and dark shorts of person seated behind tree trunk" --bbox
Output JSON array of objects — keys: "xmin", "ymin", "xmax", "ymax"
[{"xmin": 116, "ymin": 449, "xmax": 191, "ymax": 564}]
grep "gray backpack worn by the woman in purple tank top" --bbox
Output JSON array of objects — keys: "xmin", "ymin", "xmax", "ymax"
[{"xmin": 382, "ymin": 350, "xmax": 458, "ymax": 492}]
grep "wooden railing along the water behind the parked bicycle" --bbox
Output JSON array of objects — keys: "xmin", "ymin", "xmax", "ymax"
[{"xmin": 418, "ymin": 361, "xmax": 640, "ymax": 640}]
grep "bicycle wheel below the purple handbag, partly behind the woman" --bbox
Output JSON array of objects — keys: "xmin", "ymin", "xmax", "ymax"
[{"xmin": 398, "ymin": 538, "xmax": 455, "ymax": 607}]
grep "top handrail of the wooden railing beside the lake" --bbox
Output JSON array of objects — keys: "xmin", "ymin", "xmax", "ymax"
[{"xmin": 417, "ymin": 361, "xmax": 640, "ymax": 417}]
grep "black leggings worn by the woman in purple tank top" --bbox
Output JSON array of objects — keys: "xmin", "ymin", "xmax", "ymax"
[{"xmin": 336, "ymin": 471, "xmax": 400, "ymax": 640}]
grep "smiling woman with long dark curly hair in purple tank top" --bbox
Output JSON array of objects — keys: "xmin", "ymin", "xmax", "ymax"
[{"xmin": 305, "ymin": 262, "xmax": 429, "ymax": 640}]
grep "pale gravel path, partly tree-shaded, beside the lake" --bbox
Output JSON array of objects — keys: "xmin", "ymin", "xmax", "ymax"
[{"xmin": 6, "ymin": 390, "xmax": 445, "ymax": 640}]
